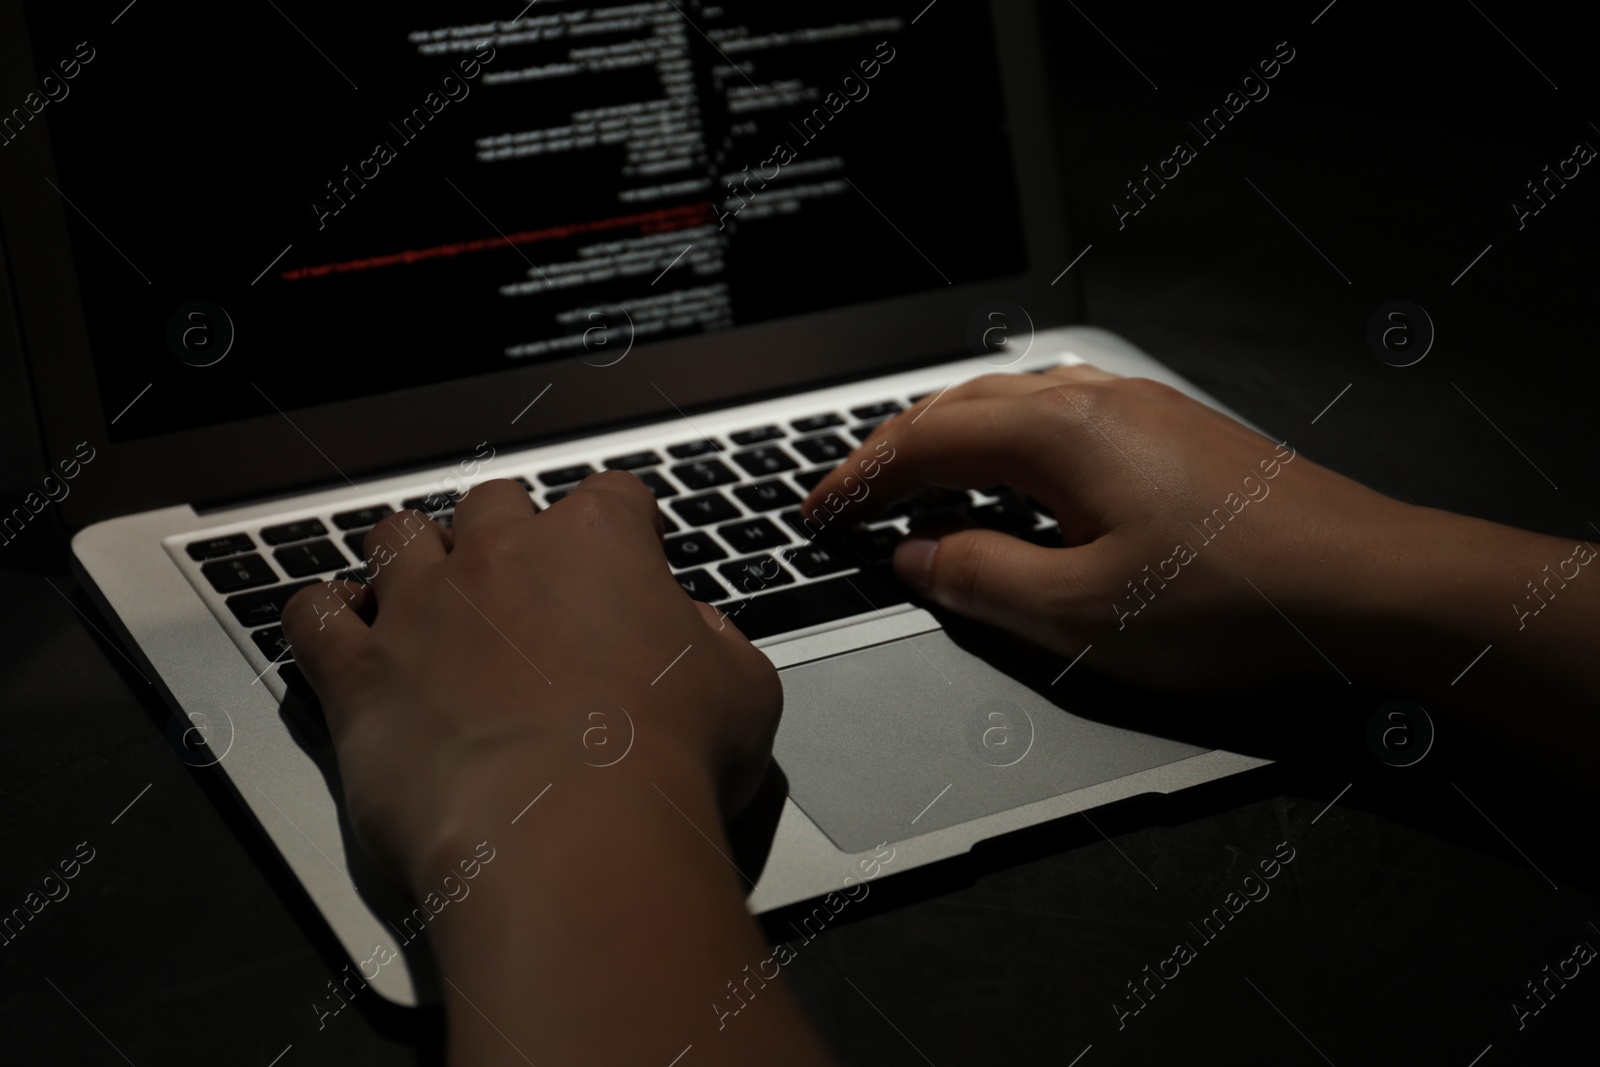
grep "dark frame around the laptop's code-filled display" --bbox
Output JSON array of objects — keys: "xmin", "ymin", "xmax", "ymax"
[{"xmin": 0, "ymin": 0, "xmax": 1082, "ymax": 530}]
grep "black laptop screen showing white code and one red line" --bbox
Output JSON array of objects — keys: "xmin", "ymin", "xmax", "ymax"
[{"xmin": 18, "ymin": 0, "xmax": 1029, "ymax": 442}]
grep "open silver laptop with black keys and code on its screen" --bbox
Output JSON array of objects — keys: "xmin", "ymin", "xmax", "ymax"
[{"xmin": 0, "ymin": 0, "xmax": 1264, "ymax": 1005}]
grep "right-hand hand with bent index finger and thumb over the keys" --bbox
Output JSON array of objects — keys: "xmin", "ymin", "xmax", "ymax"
[{"xmin": 803, "ymin": 365, "xmax": 1427, "ymax": 691}]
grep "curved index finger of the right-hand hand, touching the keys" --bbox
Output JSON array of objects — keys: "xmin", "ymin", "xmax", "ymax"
[{"xmin": 802, "ymin": 390, "xmax": 1075, "ymax": 523}]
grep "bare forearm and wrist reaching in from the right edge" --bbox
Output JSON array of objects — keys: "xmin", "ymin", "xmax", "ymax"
[{"xmin": 1323, "ymin": 507, "xmax": 1600, "ymax": 795}]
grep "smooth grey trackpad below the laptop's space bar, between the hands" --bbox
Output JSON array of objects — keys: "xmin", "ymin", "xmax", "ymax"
[{"xmin": 774, "ymin": 630, "xmax": 1206, "ymax": 853}]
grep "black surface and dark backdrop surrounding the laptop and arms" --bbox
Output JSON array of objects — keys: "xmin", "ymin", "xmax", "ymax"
[{"xmin": 0, "ymin": 0, "xmax": 1600, "ymax": 1067}]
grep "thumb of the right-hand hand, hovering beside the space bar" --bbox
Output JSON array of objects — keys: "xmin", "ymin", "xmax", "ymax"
[{"xmin": 894, "ymin": 530, "xmax": 1080, "ymax": 645}]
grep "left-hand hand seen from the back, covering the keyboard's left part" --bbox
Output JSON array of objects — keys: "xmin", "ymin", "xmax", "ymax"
[{"xmin": 283, "ymin": 472, "xmax": 782, "ymax": 891}]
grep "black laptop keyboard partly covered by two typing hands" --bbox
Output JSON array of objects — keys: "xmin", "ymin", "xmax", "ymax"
[{"xmin": 175, "ymin": 391, "xmax": 1061, "ymax": 686}]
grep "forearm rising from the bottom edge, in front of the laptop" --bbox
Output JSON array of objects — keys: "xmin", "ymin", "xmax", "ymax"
[{"xmin": 435, "ymin": 751, "xmax": 830, "ymax": 1067}]
